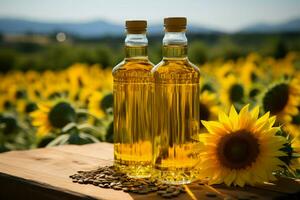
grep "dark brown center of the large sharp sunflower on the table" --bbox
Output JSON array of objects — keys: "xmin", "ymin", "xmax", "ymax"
[{"xmin": 217, "ymin": 130, "xmax": 259, "ymax": 169}]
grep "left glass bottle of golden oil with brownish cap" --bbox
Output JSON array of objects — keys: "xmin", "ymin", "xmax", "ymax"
[{"xmin": 112, "ymin": 21, "xmax": 153, "ymax": 178}]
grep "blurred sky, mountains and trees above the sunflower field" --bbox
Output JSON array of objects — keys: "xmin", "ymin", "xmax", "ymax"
[{"xmin": 0, "ymin": 0, "xmax": 300, "ymax": 72}]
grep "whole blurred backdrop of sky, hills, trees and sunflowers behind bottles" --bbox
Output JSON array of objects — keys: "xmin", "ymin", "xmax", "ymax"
[{"xmin": 0, "ymin": 0, "xmax": 300, "ymax": 151}]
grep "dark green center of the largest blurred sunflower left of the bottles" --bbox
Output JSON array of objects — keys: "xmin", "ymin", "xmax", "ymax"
[{"xmin": 48, "ymin": 102, "xmax": 76, "ymax": 128}]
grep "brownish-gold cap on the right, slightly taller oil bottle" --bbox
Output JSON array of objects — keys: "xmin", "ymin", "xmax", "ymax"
[{"xmin": 164, "ymin": 17, "xmax": 187, "ymax": 32}]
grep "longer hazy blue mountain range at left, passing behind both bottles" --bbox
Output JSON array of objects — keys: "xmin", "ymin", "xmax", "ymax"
[{"xmin": 0, "ymin": 18, "xmax": 216, "ymax": 37}]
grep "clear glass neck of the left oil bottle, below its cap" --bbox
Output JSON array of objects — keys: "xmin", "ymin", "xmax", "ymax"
[{"xmin": 125, "ymin": 33, "xmax": 148, "ymax": 59}]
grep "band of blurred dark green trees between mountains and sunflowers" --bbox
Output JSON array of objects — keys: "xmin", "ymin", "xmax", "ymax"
[{"xmin": 0, "ymin": 33, "xmax": 300, "ymax": 72}]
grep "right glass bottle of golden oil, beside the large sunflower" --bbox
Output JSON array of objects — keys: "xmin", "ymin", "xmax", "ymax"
[{"xmin": 152, "ymin": 17, "xmax": 200, "ymax": 184}]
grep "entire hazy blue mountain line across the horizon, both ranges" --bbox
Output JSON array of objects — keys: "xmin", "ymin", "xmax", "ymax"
[{"xmin": 0, "ymin": 18, "xmax": 300, "ymax": 37}]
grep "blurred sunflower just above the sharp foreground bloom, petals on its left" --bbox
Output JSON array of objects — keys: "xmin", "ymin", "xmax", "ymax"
[{"xmin": 220, "ymin": 75, "xmax": 245, "ymax": 110}]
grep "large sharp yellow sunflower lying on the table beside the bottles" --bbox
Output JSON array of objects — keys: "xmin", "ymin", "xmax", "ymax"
[{"xmin": 198, "ymin": 105, "xmax": 286, "ymax": 187}]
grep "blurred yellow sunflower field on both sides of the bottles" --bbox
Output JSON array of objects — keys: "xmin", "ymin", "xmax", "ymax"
[{"xmin": 0, "ymin": 52, "xmax": 300, "ymax": 181}]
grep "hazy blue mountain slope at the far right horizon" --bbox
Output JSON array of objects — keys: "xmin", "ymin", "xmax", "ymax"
[{"xmin": 239, "ymin": 18, "xmax": 300, "ymax": 33}]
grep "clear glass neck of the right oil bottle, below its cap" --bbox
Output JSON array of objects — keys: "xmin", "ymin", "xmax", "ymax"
[{"xmin": 163, "ymin": 32, "xmax": 187, "ymax": 59}]
